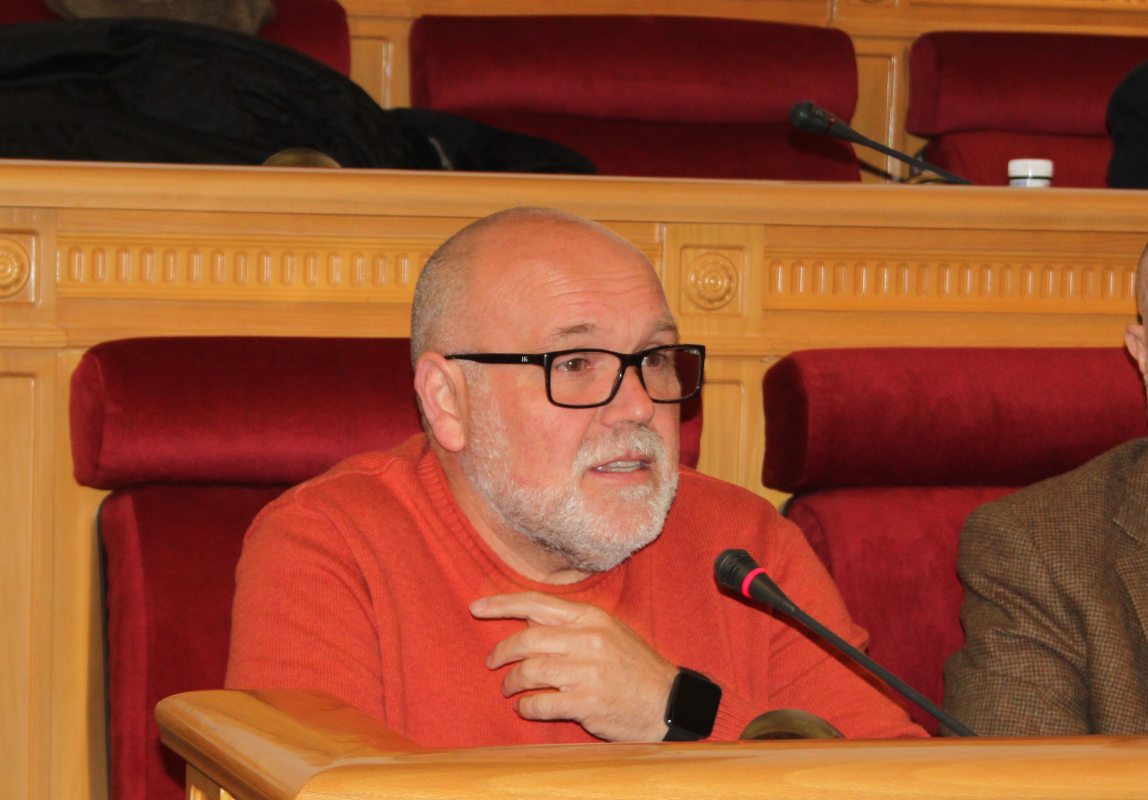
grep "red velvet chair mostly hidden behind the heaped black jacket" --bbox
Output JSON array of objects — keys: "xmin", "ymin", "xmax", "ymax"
[{"xmin": 0, "ymin": 0, "xmax": 351, "ymax": 75}]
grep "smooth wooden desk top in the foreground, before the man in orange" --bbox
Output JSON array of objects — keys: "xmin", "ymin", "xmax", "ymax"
[{"xmin": 157, "ymin": 690, "xmax": 1148, "ymax": 800}]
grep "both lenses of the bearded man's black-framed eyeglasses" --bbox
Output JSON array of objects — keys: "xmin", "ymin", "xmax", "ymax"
[{"xmin": 550, "ymin": 347, "xmax": 701, "ymax": 405}]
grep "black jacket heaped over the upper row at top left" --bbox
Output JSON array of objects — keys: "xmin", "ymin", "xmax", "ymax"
[{"xmin": 0, "ymin": 18, "xmax": 594, "ymax": 172}]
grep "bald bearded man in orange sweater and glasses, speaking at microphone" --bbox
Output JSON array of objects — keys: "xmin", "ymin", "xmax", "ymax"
[{"xmin": 227, "ymin": 209, "xmax": 923, "ymax": 746}]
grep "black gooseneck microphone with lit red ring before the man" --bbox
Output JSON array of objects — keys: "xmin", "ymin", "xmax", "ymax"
[{"xmin": 714, "ymin": 550, "xmax": 976, "ymax": 736}]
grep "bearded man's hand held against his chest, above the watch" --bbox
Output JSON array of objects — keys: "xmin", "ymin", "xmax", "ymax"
[{"xmin": 471, "ymin": 592, "xmax": 677, "ymax": 741}]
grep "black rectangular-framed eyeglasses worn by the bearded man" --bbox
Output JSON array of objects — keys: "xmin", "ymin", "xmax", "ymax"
[{"xmin": 447, "ymin": 344, "xmax": 706, "ymax": 409}]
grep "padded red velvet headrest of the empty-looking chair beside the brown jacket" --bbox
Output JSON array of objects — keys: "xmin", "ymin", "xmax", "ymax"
[{"xmin": 762, "ymin": 347, "xmax": 1148, "ymax": 492}]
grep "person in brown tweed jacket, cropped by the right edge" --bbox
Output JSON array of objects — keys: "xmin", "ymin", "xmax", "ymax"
[{"xmin": 945, "ymin": 249, "xmax": 1148, "ymax": 736}]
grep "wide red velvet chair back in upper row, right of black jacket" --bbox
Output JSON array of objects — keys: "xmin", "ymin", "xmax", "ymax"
[{"xmin": 410, "ymin": 16, "xmax": 861, "ymax": 181}]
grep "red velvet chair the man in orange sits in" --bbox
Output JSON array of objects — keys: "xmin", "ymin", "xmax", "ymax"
[{"xmin": 71, "ymin": 337, "xmax": 701, "ymax": 800}]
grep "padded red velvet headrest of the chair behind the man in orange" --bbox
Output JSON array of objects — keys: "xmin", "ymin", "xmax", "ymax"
[{"xmin": 71, "ymin": 337, "xmax": 419, "ymax": 489}]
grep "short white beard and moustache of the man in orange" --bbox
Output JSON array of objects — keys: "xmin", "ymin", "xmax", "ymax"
[{"xmin": 459, "ymin": 385, "xmax": 677, "ymax": 573}]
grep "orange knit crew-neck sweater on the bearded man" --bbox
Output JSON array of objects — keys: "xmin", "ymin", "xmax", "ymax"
[{"xmin": 227, "ymin": 436, "xmax": 924, "ymax": 746}]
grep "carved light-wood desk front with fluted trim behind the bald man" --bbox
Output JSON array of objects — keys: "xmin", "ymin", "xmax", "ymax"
[{"xmin": 0, "ymin": 162, "xmax": 1148, "ymax": 798}]
